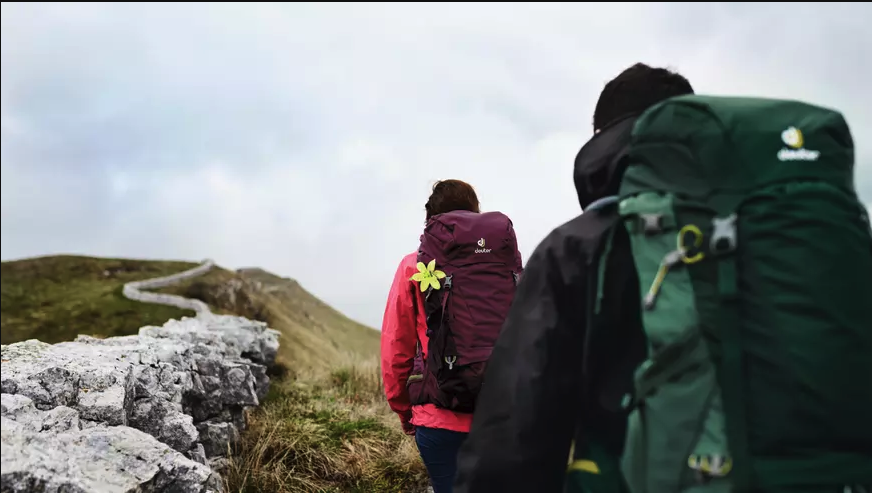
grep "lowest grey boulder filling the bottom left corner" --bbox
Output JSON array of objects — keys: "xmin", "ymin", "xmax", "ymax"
[{"xmin": 0, "ymin": 412, "xmax": 222, "ymax": 493}]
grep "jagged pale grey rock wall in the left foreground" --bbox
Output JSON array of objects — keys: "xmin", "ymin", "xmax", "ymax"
[{"xmin": 0, "ymin": 314, "xmax": 278, "ymax": 492}]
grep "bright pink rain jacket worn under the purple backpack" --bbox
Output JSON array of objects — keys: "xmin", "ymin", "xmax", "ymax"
[{"xmin": 381, "ymin": 252, "xmax": 472, "ymax": 432}]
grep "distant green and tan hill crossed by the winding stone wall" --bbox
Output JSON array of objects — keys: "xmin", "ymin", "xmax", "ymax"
[{"xmin": 0, "ymin": 256, "xmax": 379, "ymax": 368}]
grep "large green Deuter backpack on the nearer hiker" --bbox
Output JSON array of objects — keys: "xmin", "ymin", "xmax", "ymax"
[{"xmin": 570, "ymin": 95, "xmax": 872, "ymax": 493}]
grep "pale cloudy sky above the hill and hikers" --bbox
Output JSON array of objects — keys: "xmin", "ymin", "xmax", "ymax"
[{"xmin": 0, "ymin": 2, "xmax": 872, "ymax": 327}]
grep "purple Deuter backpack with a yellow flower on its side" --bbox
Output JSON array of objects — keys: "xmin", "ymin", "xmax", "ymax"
[{"xmin": 408, "ymin": 211, "xmax": 523, "ymax": 413}]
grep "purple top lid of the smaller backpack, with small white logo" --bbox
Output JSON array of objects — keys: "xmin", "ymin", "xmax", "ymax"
[{"xmin": 418, "ymin": 211, "xmax": 517, "ymax": 265}]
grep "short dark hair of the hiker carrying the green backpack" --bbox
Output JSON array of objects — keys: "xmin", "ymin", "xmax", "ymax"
[{"xmin": 593, "ymin": 63, "xmax": 693, "ymax": 130}]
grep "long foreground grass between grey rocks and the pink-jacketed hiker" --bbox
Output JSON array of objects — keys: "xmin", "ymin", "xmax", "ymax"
[{"xmin": 224, "ymin": 363, "xmax": 428, "ymax": 493}]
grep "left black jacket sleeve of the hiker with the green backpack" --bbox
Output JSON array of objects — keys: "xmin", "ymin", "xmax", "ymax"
[{"xmin": 454, "ymin": 228, "xmax": 587, "ymax": 493}]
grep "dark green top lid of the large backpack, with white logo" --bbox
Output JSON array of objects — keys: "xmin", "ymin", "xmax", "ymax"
[{"xmin": 620, "ymin": 95, "xmax": 854, "ymax": 199}]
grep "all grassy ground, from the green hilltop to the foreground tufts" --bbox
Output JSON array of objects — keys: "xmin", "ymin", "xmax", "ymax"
[{"xmin": 0, "ymin": 256, "xmax": 427, "ymax": 493}]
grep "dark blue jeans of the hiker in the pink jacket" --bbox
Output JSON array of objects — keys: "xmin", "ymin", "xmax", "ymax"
[{"xmin": 415, "ymin": 426, "xmax": 467, "ymax": 493}]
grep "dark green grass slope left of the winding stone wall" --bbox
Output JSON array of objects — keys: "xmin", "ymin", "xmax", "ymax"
[{"xmin": 0, "ymin": 256, "xmax": 197, "ymax": 344}]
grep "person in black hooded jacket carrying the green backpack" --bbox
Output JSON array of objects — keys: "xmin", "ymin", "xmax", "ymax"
[{"xmin": 454, "ymin": 63, "xmax": 693, "ymax": 493}]
